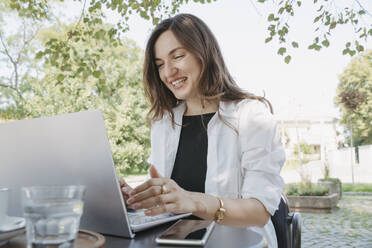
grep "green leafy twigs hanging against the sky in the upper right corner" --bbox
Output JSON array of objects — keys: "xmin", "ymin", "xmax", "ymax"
[{"xmin": 258, "ymin": 0, "xmax": 372, "ymax": 63}]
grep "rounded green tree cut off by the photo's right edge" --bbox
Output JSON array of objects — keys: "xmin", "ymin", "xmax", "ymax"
[{"xmin": 335, "ymin": 50, "xmax": 372, "ymax": 145}]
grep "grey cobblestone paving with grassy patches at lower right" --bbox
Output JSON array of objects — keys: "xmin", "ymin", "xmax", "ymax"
[{"xmin": 301, "ymin": 195, "xmax": 372, "ymax": 248}]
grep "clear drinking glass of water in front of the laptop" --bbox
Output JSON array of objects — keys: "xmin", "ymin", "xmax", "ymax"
[{"xmin": 22, "ymin": 185, "xmax": 85, "ymax": 248}]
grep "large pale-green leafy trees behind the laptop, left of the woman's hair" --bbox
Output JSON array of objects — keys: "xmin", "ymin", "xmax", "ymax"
[{"xmin": 29, "ymin": 25, "xmax": 149, "ymax": 172}]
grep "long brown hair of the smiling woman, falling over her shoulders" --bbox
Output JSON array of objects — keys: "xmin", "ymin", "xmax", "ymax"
[{"xmin": 143, "ymin": 14, "xmax": 272, "ymax": 126}]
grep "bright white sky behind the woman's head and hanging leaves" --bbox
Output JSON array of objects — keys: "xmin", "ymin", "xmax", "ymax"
[{"xmin": 121, "ymin": 0, "xmax": 372, "ymax": 118}]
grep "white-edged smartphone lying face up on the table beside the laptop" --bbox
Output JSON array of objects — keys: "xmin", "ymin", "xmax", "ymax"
[{"xmin": 156, "ymin": 220, "xmax": 214, "ymax": 246}]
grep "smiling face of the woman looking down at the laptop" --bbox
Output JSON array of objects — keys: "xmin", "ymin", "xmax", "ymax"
[{"xmin": 154, "ymin": 30, "xmax": 201, "ymax": 101}]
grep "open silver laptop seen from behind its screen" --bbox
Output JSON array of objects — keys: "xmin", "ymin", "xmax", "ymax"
[{"xmin": 0, "ymin": 111, "xmax": 189, "ymax": 238}]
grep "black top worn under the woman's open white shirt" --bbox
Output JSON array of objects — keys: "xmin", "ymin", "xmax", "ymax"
[{"xmin": 171, "ymin": 113, "xmax": 215, "ymax": 193}]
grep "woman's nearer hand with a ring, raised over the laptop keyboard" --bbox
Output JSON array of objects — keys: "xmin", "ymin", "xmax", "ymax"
[{"xmin": 125, "ymin": 166, "xmax": 196, "ymax": 215}]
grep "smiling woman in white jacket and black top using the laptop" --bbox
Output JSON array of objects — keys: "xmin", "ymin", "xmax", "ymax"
[{"xmin": 121, "ymin": 14, "xmax": 285, "ymax": 247}]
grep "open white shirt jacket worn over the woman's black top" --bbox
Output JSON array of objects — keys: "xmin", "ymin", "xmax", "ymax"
[{"xmin": 148, "ymin": 99, "xmax": 285, "ymax": 247}]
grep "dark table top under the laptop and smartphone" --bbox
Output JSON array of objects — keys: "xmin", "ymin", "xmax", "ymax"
[{"xmin": 105, "ymin": 222, "xmax": 265, "ymax": 248}]
